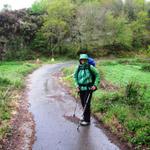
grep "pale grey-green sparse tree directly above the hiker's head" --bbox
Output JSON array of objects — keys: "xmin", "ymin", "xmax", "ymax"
[{"xmin": 74, "ymin": 3, "xmax": 107, "ymax": 47}]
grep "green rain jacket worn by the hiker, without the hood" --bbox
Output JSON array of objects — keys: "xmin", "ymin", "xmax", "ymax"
[{"xmin": 74, "ymin": 63, "xmax": 100, "ymax": 91}]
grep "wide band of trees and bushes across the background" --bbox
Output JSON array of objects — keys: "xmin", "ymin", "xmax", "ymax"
[{"xmin": 0, "ymin": 0, "xmax": 150, "ymax": 59}]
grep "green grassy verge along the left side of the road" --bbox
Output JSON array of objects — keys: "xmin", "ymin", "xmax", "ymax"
[{"xmin": 0, "ymin": 61, "xmax": 38, "ymax": 139}]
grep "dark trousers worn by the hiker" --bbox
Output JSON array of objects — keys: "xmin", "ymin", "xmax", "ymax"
[{"xmin": 80, "ymin": 90, "xmax": 92, "ymax": 122}]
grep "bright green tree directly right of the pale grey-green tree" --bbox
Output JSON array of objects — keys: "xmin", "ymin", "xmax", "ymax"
[{"xmin": 104, "ymin": 12, "xmax": 132, "ymax": 48}]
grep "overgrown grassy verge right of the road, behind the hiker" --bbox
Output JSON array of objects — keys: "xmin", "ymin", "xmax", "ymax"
[{"xmin": 63, "ymin": 59, "xmax": 150, "ymax": 149}]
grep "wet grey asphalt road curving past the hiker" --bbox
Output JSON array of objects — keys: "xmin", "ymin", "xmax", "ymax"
[{"xmin": 28, "ymin": 64, "xmax": 119, "ymax": 150}]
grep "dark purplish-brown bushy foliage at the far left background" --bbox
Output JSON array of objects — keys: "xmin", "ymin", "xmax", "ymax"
[{"xmin": 0, "ymin": 9, "xmax": 42, "ymax": 59}]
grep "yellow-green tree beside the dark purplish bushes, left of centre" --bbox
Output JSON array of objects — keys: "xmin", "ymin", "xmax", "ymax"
[{"xmin": 41, "ymin": 0, "xmax": 75, "ymax": 55}]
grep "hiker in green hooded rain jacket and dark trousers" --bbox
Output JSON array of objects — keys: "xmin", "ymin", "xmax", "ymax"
[{"xmin": 74, "ymin": 54, "xmax": 100, "ymax": 126}]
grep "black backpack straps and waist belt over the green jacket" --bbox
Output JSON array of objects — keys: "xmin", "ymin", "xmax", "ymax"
[{"xmin": 77, "ymin": 64, "xmax": 96, "ymax": 87}]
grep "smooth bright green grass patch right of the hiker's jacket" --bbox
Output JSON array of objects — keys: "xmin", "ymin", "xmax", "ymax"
[{"xmin": 100, "ymin": 64, "xmax": 150, "ymax": 85}]
